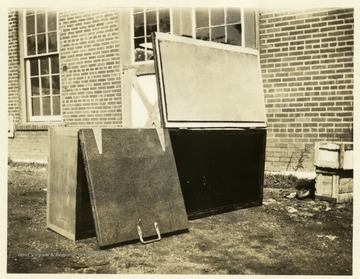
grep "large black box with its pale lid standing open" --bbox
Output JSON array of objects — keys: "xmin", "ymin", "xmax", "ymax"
[{"xmin": 153, "ymin": 33, "xmax": 266, "ymax": 218}]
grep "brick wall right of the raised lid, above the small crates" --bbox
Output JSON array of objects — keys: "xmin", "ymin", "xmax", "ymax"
[{"xmin": 260, "ymin": 9, "xmax": 354, "ymax": 171}]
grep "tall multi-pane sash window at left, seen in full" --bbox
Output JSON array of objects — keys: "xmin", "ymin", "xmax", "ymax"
[{"xmin": 24, "ymin": 10, "xmax": 61, "ymax": 121}]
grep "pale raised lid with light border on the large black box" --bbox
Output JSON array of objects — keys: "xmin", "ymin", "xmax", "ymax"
[{"xmin": 153, "ymin": 33, "xmax": 266, "ymax": 128}]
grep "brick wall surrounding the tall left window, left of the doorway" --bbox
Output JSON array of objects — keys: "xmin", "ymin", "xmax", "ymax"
[{"xmin": 8, "ymin": 10, "xmax": 122, "ymax": 162}]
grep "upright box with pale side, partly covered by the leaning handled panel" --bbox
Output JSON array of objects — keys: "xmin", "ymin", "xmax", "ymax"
[{"xmin": 47, "ymin": 128, "xmax": 95, "ymax": 240}]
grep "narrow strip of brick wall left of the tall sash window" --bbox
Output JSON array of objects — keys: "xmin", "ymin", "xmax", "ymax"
[{"xmin": 8, "ymin": 11, "xmax": 21, "ymax": 122}]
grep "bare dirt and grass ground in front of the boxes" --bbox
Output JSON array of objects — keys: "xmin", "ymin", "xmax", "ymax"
[{"xmin": 7, "ymin": 165, "xmax": 353, "ymax": 275}]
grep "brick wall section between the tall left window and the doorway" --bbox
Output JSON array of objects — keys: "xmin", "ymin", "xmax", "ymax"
[{"xmin": 59, "ymin": 10, "xmax": 122, "ymax": 127}]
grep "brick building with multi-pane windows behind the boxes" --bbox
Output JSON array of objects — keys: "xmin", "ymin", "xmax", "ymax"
[{"xmin": 8, "ymin": 8, "xmax": 354, "ymax": 171}]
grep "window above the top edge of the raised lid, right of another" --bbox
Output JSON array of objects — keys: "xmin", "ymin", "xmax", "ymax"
[{"xmin": 195, "ymin": 8, "xmax": 242, "ymax": 46}]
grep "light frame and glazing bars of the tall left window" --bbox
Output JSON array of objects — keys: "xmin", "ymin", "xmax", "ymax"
[{"xmin": 21, "ymin": 9, "xmax": 63, "ymax": 122}]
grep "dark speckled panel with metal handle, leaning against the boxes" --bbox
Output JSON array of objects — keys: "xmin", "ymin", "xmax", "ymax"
[{"xmin": 80, "ymin": 129, "xmax": 188, "ymax": 247}]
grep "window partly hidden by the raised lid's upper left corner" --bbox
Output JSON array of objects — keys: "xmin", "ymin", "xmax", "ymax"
[{"xmin": 133, "ymin": 8, "xmax": 171, "ymax": 62}]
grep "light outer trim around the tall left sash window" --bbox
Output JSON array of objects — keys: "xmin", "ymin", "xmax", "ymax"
[{"xmin": 22, "ymin": 9, "xmax": 63, "ymax": 122}]
